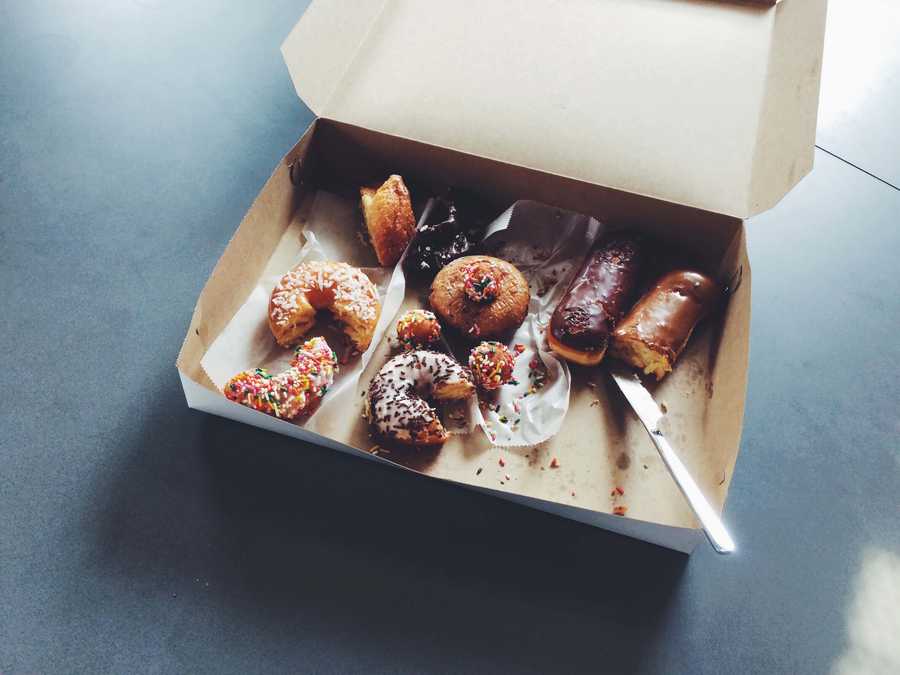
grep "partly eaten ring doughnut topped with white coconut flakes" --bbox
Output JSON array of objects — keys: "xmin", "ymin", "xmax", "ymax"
[{"xmin": 269, "ymin": 261, "xmax": 381, "ymax": 352}]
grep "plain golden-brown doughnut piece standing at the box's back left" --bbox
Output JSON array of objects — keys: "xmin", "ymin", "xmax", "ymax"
[{"xmin": 359, "ymin": 175, "xmax": 416, "ymax": 267}]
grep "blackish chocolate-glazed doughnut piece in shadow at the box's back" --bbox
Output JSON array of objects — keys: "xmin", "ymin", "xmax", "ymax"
[{"xmin": 403, "ymin": 191, "xmax": 487, "ymax": 280}]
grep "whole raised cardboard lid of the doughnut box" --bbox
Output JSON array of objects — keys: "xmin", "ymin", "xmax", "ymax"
[{"xmin": 282, "ymin": 0, "xmax": 826, "ymax": 218}]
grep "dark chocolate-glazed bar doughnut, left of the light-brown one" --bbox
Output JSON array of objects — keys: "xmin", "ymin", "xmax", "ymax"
[{"xmin": 547, "ymin": 237, "xmax": 643, "ymax": 366}]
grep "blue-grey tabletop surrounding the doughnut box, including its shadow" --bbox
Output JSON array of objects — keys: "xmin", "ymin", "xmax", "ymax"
[{"xmin": 0, "ymin": 0, "xmax": 900, "ymax": 674}]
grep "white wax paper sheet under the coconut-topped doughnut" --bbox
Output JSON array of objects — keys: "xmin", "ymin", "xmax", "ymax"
[{"xmin": 200, "ymin": 190, "xmax": 406, "ymax": 431}]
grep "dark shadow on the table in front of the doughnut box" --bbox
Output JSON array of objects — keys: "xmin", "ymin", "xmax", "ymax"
[{"xmin": 89, "ymin": 378, "xmax": 688, "ymax": 672}]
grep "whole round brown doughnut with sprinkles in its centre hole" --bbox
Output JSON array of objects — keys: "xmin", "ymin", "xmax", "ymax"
[{"xmin": 429, "ymin": 255, "xmax": 530, "ymax": 339}]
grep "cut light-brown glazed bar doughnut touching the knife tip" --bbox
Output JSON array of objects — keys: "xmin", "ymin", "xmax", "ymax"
[{"xmin": 610, "ymin": 270, "xmax": 723, "ymax": 380}]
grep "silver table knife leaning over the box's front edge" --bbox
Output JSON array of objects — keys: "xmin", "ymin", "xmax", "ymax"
[{"xmin": 609, "ymin": 364, "xmax": 736, "ymax": 554}]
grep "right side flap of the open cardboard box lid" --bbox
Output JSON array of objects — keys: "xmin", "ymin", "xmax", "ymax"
[{"xmin": 747, "ymin": 0, "xmax": 828, "ymax": 215}]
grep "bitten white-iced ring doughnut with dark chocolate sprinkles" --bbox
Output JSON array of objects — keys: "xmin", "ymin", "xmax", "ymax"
[{"xmin": 366, "ymin": 350, "xmax": 475, "ymax": 445}]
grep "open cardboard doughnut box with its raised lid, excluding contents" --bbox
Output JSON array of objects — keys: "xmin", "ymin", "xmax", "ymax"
[{"xmin": 177, "ymin": 0, "xmax": 826, "ymax": 552}]
